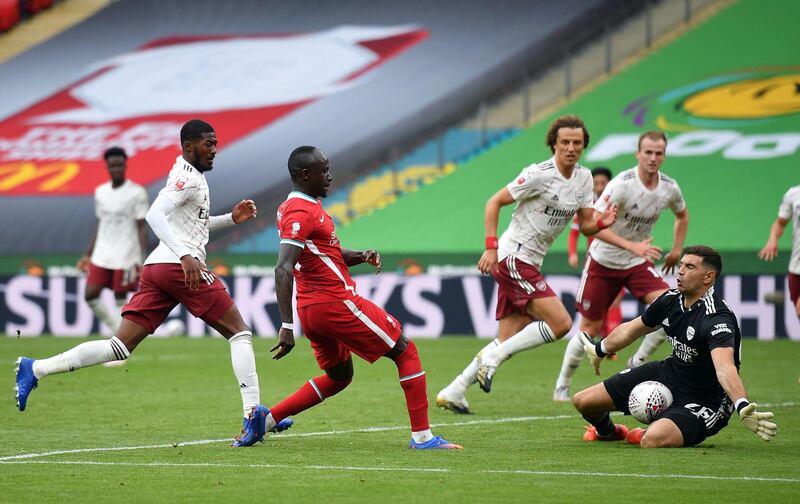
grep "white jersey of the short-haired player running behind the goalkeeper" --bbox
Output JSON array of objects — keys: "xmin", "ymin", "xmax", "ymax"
[{"xmin": 589, "ymin": 167, "xmax": 686, "ymax": 269}]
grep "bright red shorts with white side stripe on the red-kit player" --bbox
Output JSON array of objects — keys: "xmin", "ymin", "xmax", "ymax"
[{"xmin": 297, "ymin": 296, "xmax": 403, "ymax": 370}]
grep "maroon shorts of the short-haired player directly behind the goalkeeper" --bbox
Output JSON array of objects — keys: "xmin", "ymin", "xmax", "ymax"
[{"xmin": 575, "ymin": 255, "xmax": 669, "ymax": 320}]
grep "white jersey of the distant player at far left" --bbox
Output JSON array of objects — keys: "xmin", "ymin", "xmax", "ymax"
[{"xmin": 91, "ymin": 180, "xmax": 148, "ymax": 269}]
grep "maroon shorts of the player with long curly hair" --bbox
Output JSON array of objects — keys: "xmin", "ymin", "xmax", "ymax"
[{"xmin": 494, "ymin": 255, "xmax": 556, "ymax": 320}]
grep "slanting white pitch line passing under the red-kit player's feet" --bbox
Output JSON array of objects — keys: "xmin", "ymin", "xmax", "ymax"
[{"xmin": 0, "ymin": 415, "xmax": 575, "ymax": 462}]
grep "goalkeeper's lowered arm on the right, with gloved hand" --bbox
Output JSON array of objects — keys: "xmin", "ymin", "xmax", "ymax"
[{"xmin": 711, "ymin": 347, "xmax": 778, "ymax": 441}]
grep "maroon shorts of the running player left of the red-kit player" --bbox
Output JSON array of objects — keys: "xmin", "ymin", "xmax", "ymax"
[{"xmin": 122, "ymin": 263, "xmax": 233, "ymax": 333}]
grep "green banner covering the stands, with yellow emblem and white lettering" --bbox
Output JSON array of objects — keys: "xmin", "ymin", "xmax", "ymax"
[{"xmin": 338, "ymin": 2, "xmax": 800, "ymax": 257}]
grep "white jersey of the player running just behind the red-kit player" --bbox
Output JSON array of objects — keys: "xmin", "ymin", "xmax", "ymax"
[{"xmin": 145, "ymin": 156, "xmax": 211, "ymax": 264}]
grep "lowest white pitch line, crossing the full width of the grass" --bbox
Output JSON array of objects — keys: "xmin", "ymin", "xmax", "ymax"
[{"xmin": 0, "ymin": 460, "xmax": 800, "ymax": 483}]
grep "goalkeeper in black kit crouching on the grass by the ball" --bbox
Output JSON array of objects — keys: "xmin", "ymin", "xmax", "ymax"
[{"xmin": 572, "ymin": 245, "xmax": 778, "ymax": 448}]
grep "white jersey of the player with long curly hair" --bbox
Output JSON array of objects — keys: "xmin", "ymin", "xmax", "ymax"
[{"xmin": 498, "ymin": 158, "xmax": 592, "ymax": 268}]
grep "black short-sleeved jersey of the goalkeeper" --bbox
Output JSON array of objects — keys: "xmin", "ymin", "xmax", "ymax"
[{"xmin": 642, "ymin": 288, "xmax": 742, "ymax": 403}]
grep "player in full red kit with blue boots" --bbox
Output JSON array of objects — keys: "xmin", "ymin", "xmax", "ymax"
[{"xmin": 256, "ymin": 146, "xmax": 462, "ymax": 449}]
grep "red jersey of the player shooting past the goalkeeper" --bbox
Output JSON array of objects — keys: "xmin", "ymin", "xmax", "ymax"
[{"xmin": 278, "ymin": 191, "xmax": 356, "ymax": 308}]
